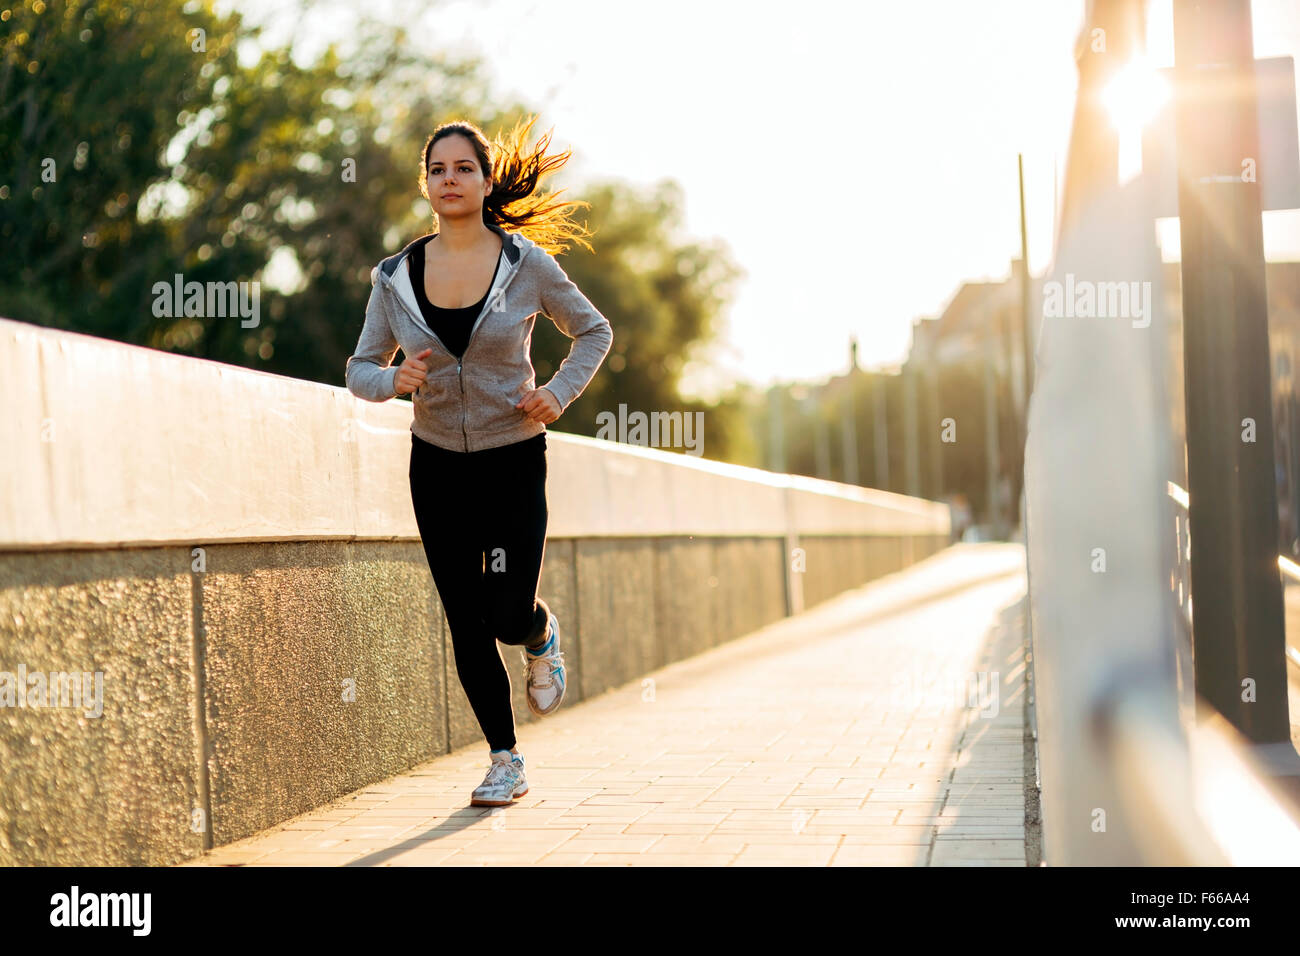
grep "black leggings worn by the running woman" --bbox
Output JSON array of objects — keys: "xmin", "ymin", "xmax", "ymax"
[{"xmin": 410, "ymin": 432, "xmax": 551, "ymax": 750}]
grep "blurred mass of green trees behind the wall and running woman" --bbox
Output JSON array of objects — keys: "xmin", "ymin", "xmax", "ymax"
[{"xmin": 0, "ymin": 0, "xmax": 745, "ymax": 458}]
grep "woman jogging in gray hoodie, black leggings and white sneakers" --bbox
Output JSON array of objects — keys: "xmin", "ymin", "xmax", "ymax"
[{"xmin": 346, "ymin": 120, "xmax": 614, "ymax": 806}]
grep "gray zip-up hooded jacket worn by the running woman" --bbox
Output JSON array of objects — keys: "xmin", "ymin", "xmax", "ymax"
[{"xmin": 346, "ymin": 225, "xmax": 614, "ymax": 451}]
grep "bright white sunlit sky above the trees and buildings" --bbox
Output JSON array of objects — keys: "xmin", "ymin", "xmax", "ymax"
[{"xmin": 223, "ymin": 0, "xmax": 1300, "ymax": 394}]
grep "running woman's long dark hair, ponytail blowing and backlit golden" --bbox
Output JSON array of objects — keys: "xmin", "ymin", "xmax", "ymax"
[{"xmin": 420, "ymin": 116, "xmax": 594, "ymax": 255}]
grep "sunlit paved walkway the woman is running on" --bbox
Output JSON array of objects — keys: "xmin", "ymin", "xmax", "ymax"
[{"xmin": 185, "ymin": 544, "xmax": 1026, "ymax": 866}]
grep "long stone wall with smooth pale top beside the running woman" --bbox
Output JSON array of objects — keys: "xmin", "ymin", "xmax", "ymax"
[{"xmin": 0, "ymin": 320, "xmax": 949, "ymax": 865}]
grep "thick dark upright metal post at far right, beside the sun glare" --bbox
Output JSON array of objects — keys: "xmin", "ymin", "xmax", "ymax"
[{"xmin": 1174, "ymin": 0, "xmax": 1295, "ymax": 760}]
